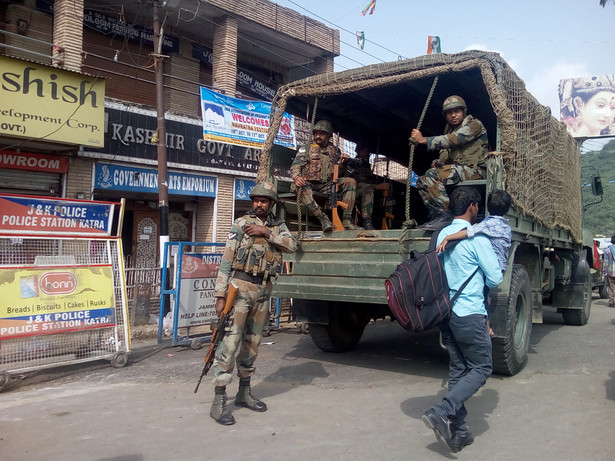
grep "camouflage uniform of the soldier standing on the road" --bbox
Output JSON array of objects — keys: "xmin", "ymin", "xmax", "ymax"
[{"xmin": 212, "ymin": 211, "xmax": 295, "ymax": 386}]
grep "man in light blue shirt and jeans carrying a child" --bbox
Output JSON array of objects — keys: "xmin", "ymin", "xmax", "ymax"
[{"xmin": 422, "ymin": 186, "xmax": 502, "ymax": 453}]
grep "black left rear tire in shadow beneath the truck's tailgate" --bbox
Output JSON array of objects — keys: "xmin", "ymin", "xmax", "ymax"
[{"xmin": 309, "ymin": 303, "xmax": 369, "ymax": 352}]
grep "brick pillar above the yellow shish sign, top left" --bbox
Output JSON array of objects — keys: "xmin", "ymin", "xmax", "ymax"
[{"xmin": 53, "ymin": 0, "xmax": 83, "ymax": 71}]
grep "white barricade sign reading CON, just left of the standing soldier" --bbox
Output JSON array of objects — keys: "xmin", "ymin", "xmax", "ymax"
[{"xmin": 177, "ymin": 253, "xmax": 222, "ymax": 328}]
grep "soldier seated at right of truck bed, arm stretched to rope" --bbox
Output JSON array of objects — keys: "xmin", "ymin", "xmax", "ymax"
[{"xmin": 410, "ymin": 95, "xmax": 489, "ymax": 230}]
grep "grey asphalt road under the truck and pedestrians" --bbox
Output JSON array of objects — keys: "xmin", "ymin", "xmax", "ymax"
[{"xmin": 0, "ymin": 297, "xmax": 615, "ymax": 461}]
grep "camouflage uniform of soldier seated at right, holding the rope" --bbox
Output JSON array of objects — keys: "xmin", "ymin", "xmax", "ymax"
[{"xmin": 416, "ymin": 115, "xmax": 489, "ymax": 216}]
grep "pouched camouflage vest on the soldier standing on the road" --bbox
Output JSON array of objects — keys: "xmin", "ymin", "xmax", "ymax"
[{"xmin": 232, "ymin": 215, "xmax": 282, "ymax": 277}]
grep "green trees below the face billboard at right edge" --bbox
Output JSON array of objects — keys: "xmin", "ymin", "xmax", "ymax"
[{"xmin": 581, "ymin": 139, "xmax": 615, "ymax": 237}]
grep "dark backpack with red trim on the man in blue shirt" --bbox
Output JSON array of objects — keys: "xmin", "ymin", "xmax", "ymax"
[{"xmin": 384, "ymin": 232, "xmax": 478, "ymax": 333}]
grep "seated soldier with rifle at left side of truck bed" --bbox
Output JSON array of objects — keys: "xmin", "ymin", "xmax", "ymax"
[{"xmin": 290, "ymin": 120, "xmax": 357, "ymax": 232}]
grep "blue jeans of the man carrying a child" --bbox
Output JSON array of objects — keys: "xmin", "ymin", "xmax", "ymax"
[{"xmin": 433, "ymin": 312, "xmax": 493, "ymax": 435}]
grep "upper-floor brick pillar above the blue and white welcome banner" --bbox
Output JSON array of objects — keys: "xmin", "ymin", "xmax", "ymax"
[{"xmin": 212, "ymin": 16, "xmax": 237, "ymax": 97}]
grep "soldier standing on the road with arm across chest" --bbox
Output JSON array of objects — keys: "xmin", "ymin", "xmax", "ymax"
[{"xmin": 209, "ymin": 182, "xmax": 295, "ymax": 426}]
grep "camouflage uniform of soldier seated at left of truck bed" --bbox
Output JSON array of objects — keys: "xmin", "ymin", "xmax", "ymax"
[{"xmin": 290, "ymin": 142, "xmax": 357, "ymax": 219}]
